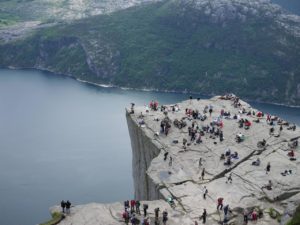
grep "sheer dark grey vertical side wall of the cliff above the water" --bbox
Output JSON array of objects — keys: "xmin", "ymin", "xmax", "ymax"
[{"xmin": 126, "ymin": 111, "xmax": 161, "ymax": 200}]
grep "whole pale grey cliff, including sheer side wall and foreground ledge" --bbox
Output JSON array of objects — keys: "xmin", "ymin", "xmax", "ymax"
[{"xmin": 49, "ymin": 96, "xmax": 300, "ymax": 225}]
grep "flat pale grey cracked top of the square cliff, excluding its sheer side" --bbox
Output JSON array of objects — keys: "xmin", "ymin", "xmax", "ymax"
[{"xmin": 129, "ymin": 97, "xmax": 300, "ymax": 224}]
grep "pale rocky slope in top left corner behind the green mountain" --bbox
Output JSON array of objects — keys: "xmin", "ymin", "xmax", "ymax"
[{"xmin": 0, "ymin": 0, "xmax": 158, "ymax": 25}]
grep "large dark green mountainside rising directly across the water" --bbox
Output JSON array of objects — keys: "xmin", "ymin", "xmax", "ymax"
[{"xmin": 0, "ymin": 0, "xmax": 300, "ymax": 105}]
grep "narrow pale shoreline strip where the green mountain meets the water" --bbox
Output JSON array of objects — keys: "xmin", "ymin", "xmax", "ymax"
[{"xmin": 0, "ymin": 66, "xmax": 300, "ymax": 108}]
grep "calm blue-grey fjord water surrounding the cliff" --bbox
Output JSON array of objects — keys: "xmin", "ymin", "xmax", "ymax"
[{"xmin": 0, "ymin": 69, "xmax": 300, "ymax": 225}]
